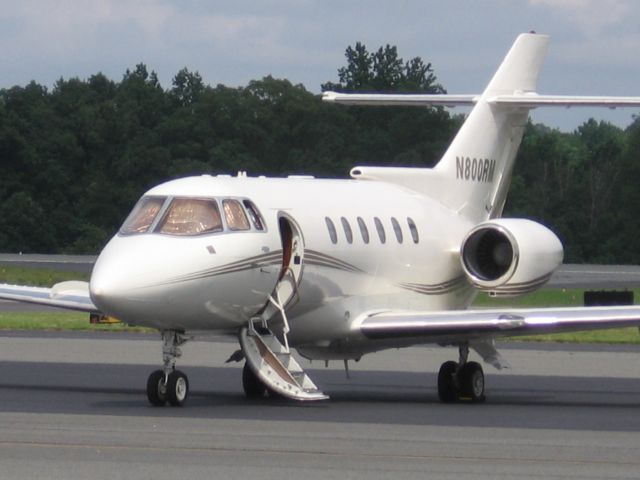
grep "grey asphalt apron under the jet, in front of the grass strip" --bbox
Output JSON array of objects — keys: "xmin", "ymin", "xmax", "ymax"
[{"xmin": 0, "ymin": 332, "xmax": 640, "ymax": 480}]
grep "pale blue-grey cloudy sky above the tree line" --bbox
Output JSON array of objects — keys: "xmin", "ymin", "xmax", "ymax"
[{"xmin": 0, "ymin": 0, "xmax": 640, "ymax": 131}]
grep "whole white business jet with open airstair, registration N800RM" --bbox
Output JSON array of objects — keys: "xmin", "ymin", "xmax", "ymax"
[{"xmin": 0, "ymin": 34, "xmax": 640, "ymax": 406}]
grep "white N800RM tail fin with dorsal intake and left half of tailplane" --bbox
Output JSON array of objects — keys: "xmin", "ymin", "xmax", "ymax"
[{"xmin": 340, "ymin": 34, "xmax": 548, "ymax": 222}]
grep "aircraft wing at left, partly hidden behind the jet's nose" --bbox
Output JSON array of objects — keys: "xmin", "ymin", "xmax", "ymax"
[{"xmin": 0, "ymin": 281, "xmax": 99, "ymax": 313}]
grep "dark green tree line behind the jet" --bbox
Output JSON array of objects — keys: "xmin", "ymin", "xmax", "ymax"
[{"xmin": 0, "ymin": 43, "xmax": 640, "ymax": 263}]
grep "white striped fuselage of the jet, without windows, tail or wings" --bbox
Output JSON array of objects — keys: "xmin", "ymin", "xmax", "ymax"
[{"xmin": 91, "ymin": 175, "xmax": 475, "ymax": 356}]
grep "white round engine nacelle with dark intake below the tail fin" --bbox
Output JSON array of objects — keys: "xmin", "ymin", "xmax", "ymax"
[{"xmin": 460, "ymin": 218, "xmax": 563, "ymax": 296}]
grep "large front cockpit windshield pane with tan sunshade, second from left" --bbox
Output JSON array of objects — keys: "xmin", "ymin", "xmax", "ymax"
[{"xmin": 156, "ymin": 198, "xmax": 222, "ymax": 235}]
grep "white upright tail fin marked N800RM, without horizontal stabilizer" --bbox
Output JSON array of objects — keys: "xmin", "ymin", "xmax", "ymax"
[{"xmin": 427, "ymin": 34, "xmax": 548, "ymax": 221}]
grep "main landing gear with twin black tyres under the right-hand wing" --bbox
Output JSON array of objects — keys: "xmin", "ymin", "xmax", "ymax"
[{"xmin": 438, "ymin": 343, "xmax": 485, "ymax": 403}]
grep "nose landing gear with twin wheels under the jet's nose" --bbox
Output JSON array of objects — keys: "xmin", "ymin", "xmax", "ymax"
[{"xmin": 147, "ymin": 330, "xmax": 189, "ymax": 407}]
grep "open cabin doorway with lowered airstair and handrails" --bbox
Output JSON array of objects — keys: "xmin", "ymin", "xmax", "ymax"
[{"xmin": 240, "ymin": 214, "xmax": 329, "ymax": 400}]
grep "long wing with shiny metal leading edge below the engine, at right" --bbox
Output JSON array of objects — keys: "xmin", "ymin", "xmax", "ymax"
[{"xmin": 353, "ymin": 305, "xmax": 640, "ymax": 343}]
